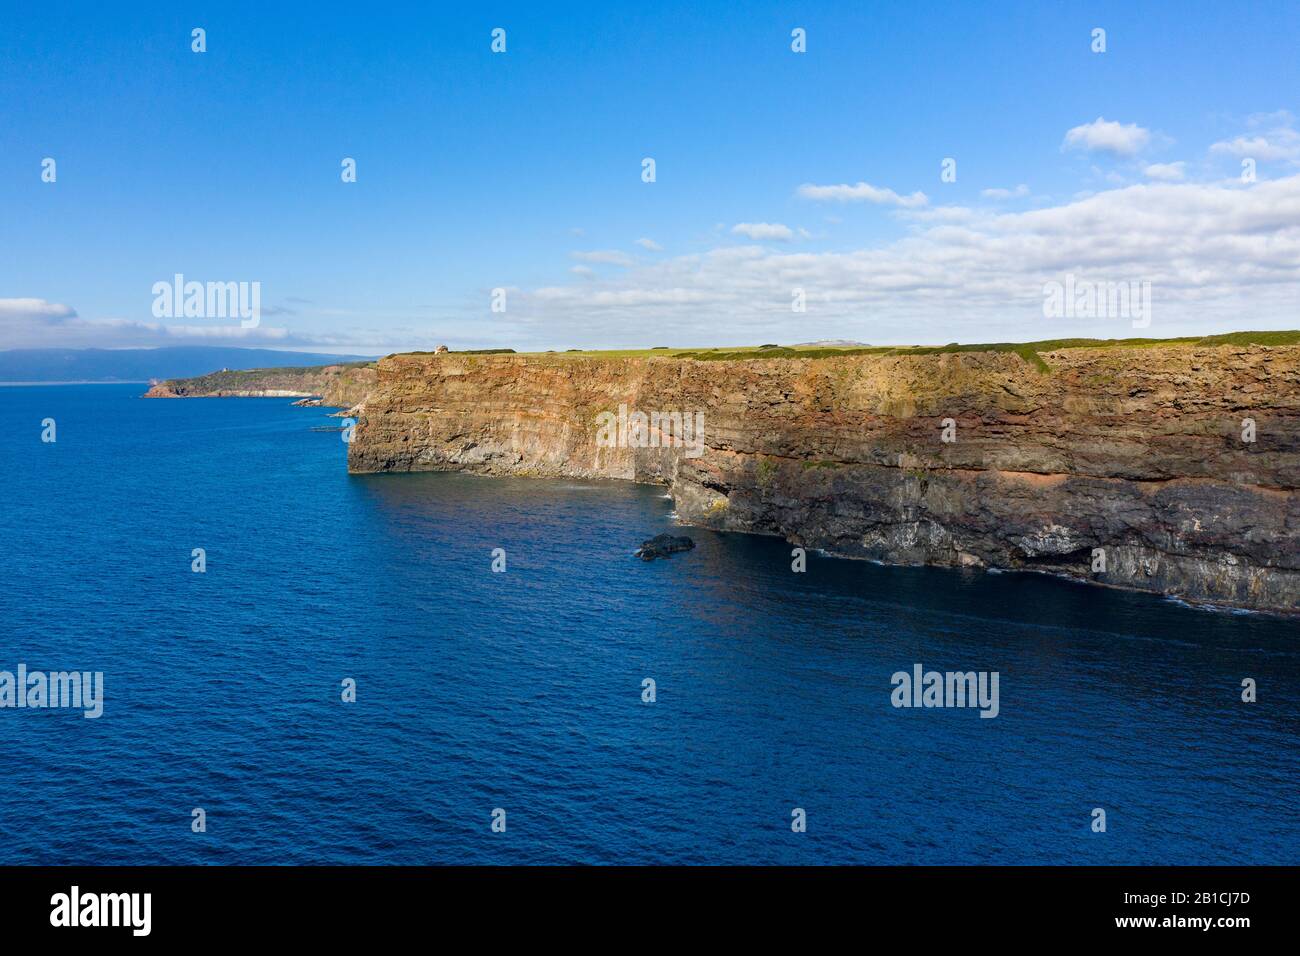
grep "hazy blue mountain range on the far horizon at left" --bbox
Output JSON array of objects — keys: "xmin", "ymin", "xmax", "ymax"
[{"xmin": 0, "ymin": 345, "xmax": 372, "ymax": 382}]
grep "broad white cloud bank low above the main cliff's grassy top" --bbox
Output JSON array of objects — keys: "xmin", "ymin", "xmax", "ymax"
[{"xmin": 511, "ymin": 174, "xmax": 1300, "ymax": 345}]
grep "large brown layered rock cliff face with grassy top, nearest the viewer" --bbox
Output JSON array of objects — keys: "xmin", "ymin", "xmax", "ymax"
[{"xmin": 348, "ymin": 346, "xmax": 1300, "ymax": 611}]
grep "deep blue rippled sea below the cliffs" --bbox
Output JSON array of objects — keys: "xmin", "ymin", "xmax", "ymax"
[{"xmin": 0, "ymin": 386, "xmax": 1300, "ymax": 864}]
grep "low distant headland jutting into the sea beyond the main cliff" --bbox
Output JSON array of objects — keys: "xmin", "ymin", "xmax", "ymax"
[{"xmin": 144, "ymin": 362, "xmax": 377, "ymax": 408}]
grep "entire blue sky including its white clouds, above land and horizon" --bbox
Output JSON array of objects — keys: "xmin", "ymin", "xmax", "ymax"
[{"xmin": 0, "ymin": 1, "xmax": 1300, "ymax": 354}]
